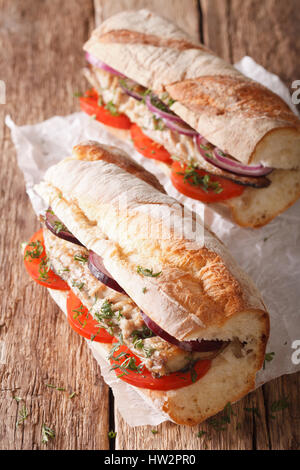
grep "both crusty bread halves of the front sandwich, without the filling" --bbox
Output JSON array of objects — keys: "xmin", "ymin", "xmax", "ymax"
[{"xmin": 32, "ymin": 142, "xmax": 269, "ymax": 425}]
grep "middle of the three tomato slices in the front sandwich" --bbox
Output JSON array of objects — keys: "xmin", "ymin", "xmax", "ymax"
[{"xmin": 67, "ymin": 290, "xmax": 114, "ymax": 343}]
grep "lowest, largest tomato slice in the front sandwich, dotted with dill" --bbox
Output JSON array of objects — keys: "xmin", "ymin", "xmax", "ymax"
[{"xmin": 110, "ymin": 338, "xmax": 211, "ymax": 390}]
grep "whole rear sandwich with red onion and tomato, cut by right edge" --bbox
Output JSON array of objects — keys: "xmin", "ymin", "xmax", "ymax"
[{"xmin": 80, "ymin": 10, "xmax": 300, "ymax": 228}]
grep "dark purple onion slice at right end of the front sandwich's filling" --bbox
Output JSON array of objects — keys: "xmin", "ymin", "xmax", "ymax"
[{"xmin": 141, "ymin": 312, "xmax": 228, "ymax": 352}]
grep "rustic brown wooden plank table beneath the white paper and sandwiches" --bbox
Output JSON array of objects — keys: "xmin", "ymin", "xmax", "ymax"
[{"xmin": 0, "ymin": 0, "xmax": 300, "ymax": 450}]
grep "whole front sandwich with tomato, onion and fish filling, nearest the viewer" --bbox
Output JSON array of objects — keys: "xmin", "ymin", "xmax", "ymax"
[{"xmin": 24, "ymin": 141, "xmax": 269, "ymax": 425}]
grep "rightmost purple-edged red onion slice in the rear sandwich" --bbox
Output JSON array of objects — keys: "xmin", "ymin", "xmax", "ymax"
[{"xmin": 196, "ymin": 134, "xmax": 273, "ymax": 176}]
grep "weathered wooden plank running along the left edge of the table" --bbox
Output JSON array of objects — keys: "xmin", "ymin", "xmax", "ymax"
[{"xmin": 0, "ymin": 0, "xmax": 109, "ymax": 449}]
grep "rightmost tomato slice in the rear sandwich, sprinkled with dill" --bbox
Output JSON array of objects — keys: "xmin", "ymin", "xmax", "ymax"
[{"xmin": 171, "ymin": 161, "xmax": 245, "ymax": 203}]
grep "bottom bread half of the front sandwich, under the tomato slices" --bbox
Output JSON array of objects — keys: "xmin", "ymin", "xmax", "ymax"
[{"xmin": 48, "ymin": 289, "xmax": 265, "ymax": 426}]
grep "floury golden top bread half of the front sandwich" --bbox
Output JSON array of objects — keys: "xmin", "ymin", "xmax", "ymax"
[{"xmin": 36, "ymin": 142, "xmax": 268, "ymax": 342}]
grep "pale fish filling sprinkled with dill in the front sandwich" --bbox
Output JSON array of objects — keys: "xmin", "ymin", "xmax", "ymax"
[{"xmin": 44, "ymin": 228, "xmax": 218, "ymax": 377}]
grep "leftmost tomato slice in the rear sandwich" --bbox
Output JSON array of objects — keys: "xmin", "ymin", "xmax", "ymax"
[{"xmin": 79, "ymin": 88, "xmax": 131, "ymax": 129}]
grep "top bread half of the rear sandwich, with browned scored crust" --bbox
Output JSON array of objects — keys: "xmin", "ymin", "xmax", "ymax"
[{"xmin": 84, "ymin": 10, "xmax": 300, "ymax": 169}]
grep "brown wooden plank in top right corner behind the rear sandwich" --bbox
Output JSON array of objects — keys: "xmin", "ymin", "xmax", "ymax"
[{"xmin": 200, "ymin": 0, "xmax": 300, "ymax": 98}]
